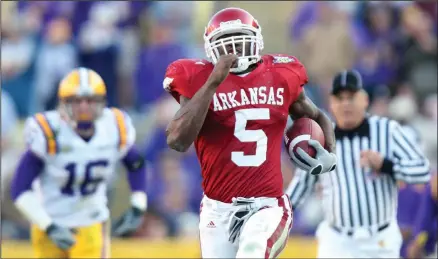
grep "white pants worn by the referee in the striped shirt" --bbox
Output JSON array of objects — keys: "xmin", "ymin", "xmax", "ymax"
[{"xmin": 316, "ymin": 221, "xmax": 402, "ymax": 258}]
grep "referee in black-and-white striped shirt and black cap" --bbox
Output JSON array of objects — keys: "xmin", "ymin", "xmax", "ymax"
[{"xmin": 286, "ymin": 70, "xmax": 430, "ymax": 258}]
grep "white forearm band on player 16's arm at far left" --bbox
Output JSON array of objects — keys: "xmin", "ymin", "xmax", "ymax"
[{"xmin": 15, "ymin": 191, "xmax": 52, "ymax": 230}]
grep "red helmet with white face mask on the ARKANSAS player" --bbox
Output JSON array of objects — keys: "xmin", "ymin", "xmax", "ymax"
[{"xmin": 204, "ymin": 8, "xmax": 263, "ymax": 73}]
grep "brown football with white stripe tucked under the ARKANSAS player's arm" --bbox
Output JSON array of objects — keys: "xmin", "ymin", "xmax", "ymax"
[{"xmin": 284, "ymin": 118, "xmax": 325, "ymax": 164}]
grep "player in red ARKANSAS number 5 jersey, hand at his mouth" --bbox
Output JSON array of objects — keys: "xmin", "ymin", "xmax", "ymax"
[{"xmin": 163, "ymin": 8, "xmax": 336, "ymax": 258}]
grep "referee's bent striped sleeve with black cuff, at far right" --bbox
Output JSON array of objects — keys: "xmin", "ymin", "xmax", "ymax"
[{"xmin": 382, "ymin": 121, "xmax": 430, "ymax": 184}]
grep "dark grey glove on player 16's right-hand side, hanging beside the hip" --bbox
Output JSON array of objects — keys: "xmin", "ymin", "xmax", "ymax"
[{"xmin": 112, "ymin": 207, "xmax": 145, "ymax": 237}]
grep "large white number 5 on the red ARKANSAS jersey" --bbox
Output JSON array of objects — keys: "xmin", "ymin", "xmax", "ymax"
[{"xmin": 231, "ymin": 108, "xmax": 270, "ymax": 167}]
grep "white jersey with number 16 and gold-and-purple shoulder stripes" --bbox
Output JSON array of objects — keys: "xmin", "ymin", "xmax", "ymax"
[{"xmin": 25, "ymin": 108, "xmax": 136, "ymax": 227}]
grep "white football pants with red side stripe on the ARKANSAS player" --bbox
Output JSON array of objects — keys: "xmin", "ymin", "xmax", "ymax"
[{"xmin": 199, "ymin": 195, "xmax": 292, "ymax": 258}]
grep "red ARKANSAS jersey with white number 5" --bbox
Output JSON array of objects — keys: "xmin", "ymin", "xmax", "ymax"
[{"xmin": 163, "ymin": 55, "xmax": 307, "ymax": 202}]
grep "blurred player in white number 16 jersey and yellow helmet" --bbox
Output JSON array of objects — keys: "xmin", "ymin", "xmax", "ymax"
[{"xmin": 11, "ymin": 68, "xmax": 147, "ymax": 258}]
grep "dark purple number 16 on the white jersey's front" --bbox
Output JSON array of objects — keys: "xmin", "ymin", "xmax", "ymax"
[{"xmin": 61, "ymin": 160, "xmax": 108, "ymax": 196}]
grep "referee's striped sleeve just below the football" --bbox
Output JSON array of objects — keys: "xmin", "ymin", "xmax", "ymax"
[{"xmin": 286, "ymin": 169, "xmax": 318, "ymax": 209}]
